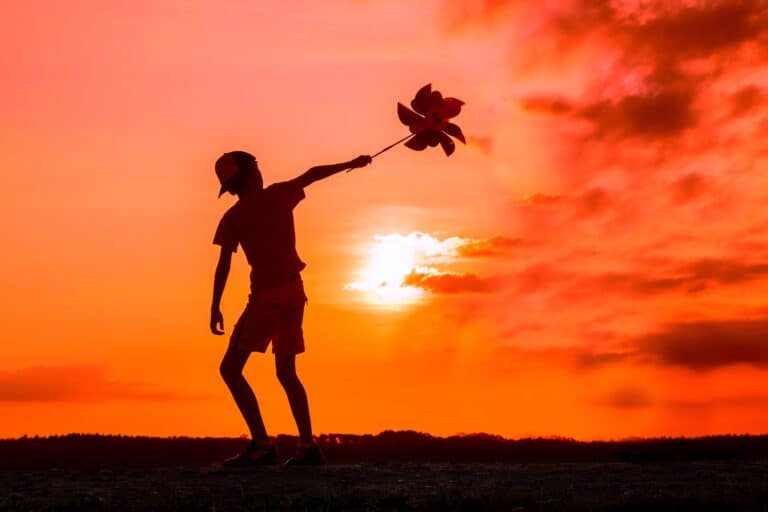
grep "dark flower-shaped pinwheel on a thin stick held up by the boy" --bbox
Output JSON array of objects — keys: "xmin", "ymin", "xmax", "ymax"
[{"xmin": 373, "ymin": 84, "xmax": 466, "ymax": 157}]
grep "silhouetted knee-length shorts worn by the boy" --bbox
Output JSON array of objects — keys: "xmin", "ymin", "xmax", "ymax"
[{"xmin": 229, "ymin": 276, "xmax": 307, "ymax": 354}]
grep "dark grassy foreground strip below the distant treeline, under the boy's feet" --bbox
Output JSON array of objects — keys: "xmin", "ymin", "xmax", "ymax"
[{"xmin": 0, "ymin": 460, "xmax": 768, "ymax": 511}]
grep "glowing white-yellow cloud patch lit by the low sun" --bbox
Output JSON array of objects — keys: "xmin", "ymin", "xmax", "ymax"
[{"xmin": 344, "ymin": 231, "xmax": 466, "ymax": 304}]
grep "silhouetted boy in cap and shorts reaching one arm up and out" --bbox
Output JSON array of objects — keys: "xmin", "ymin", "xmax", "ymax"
[{"xmin": 210, "ymin": 151, "xmax": 371, "ymax": 465}]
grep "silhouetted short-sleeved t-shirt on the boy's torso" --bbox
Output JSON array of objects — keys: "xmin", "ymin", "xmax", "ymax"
[{"xmin": 213, "ymin": 181, "xmax": 306, "ymax": 292}]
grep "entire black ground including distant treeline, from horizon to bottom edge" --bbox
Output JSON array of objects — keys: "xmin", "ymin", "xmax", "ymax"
[{"xmin": 0, "ymin": 432, "xmax": 768, "ymax": 512}]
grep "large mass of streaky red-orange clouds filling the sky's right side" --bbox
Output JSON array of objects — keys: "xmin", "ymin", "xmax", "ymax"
[{"xmin": 424, "ymin": 0, "xmax": 768, "ymax": 432}]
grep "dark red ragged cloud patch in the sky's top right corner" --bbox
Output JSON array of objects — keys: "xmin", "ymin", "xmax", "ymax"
[{"xmin": 504, "ymin": 0, "xmax": 768, "ymax": 156}]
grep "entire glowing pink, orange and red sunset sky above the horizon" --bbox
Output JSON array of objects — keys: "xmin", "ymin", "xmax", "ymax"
[{"xmin": 0, "ymin": 0, "xmax": 768, "ymax": 439}]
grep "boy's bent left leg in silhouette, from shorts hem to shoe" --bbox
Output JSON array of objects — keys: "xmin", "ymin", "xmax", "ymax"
[{"xmin": 219, "ymin": 344, "xmax": 269, "ymax": 445}]
